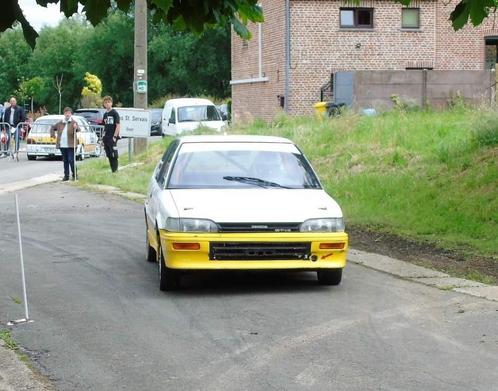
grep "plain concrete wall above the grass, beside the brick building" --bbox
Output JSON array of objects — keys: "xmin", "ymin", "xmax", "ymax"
[{"xmin": 353, "ymin": 70, "xmax": 495, "ymax": 110}]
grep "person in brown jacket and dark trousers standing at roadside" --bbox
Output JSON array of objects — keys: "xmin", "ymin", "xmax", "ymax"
[{"xmin": 50, "ymin": 107, "xmax": 80, "ymax": 181}]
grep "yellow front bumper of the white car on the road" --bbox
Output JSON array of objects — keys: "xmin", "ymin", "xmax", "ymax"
[{"xmin": 160, "ymin": 230, "xmax": 348, "ymax": 270}]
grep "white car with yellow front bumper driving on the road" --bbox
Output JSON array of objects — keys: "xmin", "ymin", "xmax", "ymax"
[{"xmin": 145, "ymin": 135, "xmax": 348, "ymax": 290}]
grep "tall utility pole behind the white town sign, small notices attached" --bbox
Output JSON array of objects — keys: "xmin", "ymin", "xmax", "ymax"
[{"xmin": 133, "ymin": 0, "xmax": 147, "ymax": 153}]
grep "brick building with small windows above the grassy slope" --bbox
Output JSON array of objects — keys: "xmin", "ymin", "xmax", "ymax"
[{"xmin": 230, "ymin": 0, "xmax": 498, "ymax": 121}]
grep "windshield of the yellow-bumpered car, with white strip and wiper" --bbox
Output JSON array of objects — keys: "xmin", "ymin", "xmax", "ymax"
[{"xmin": 167, "ymin": 143, "xmax": 321, "ymax": 189}]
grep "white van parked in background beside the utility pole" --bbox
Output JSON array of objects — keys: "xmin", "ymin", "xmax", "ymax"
[{"xmin": 161, "ymin": 98, "xmax": 226, "ymax": 136}]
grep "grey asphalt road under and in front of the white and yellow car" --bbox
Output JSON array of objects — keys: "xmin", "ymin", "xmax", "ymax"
[{"xmin": 0, "ymin": 183, "xmax": 498, "ymax": 391}]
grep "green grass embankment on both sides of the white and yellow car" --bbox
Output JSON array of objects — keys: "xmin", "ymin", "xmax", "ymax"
[{"xmin": 76, "ymin": 108, "xmax": 498, "ymax": 260}]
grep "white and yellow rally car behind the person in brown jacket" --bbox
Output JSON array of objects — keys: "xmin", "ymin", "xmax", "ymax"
[{"xmin": 26, "ymin": 115, "xmax": 101, "ymax": 160}]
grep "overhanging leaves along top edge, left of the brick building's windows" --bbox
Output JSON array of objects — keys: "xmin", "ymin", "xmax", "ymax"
[{"xmin": 0, "ymin": 0, "xmax": 263, "ymax": 48}]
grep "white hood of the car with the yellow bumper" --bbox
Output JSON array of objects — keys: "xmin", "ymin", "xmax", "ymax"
[{"xmin": 165, "ymin": 189, "xmax": 342, "ymax": 223}]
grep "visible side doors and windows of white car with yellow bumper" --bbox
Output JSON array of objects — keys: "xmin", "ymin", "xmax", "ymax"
[{"xmin": 145, "ymin": 140, "xmax": 180, "ymax": 239}]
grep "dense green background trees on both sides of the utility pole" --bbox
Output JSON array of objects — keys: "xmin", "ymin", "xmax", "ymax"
[{"xmin": 0, "ymin": 11, "xmax": 230, "ymax": 113}]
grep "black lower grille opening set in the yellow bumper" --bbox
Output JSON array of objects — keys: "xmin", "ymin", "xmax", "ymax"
[{"xmin": 209, "ymin": 242, "xmax": 311, "ymax": 261}]
